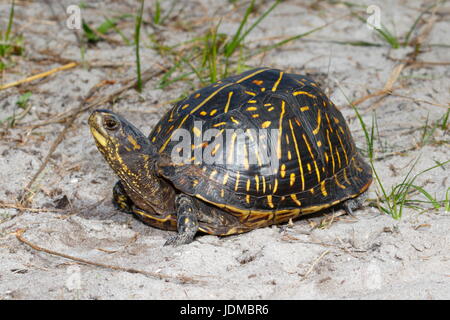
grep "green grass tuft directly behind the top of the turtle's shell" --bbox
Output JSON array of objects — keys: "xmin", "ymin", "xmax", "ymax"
[{"xmin": 150, "ymin": 0, "xmax": 329, "ymax": 89}]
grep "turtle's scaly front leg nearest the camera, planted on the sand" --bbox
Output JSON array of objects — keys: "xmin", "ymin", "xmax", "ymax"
[{"xmin": 164, "ymin": 194, "xmax": 199, "ymax": 246}]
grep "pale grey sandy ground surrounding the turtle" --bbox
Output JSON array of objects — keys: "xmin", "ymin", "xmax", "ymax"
[{"xmin": 0, "ymin": 0, "xmax": 450, "ymax": 299}]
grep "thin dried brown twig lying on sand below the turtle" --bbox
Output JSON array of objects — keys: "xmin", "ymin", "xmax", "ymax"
[{"xmin": 15, "ymin": 229, "xmax": 202, "ymax": 284}]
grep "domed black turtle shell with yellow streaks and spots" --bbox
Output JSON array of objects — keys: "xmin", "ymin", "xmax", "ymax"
[{"xmin": 149, "ymin": 68, "xmax": 372, "ymax": 220}]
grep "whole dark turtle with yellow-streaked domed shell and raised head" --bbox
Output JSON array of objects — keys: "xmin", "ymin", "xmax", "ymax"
[{"xmin": 88, "ymin": 67, "xmax": 372, "ymax": 246}]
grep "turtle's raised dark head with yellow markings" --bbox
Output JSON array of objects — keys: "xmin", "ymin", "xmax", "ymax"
[{"xmin": 89, "ymin": 109, "xmax": 157, "ymax": 180}]
